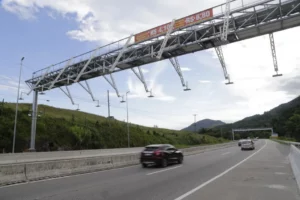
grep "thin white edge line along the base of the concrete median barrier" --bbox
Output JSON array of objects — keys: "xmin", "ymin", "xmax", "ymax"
[{"xmin": 0, "ymin": 165, "xmax": 137, "ymax": 189}]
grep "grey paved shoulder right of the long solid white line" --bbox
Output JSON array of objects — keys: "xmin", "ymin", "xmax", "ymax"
[{"xmin": 179, "ymin": 140, "xmax": 300, "ymax": 200}]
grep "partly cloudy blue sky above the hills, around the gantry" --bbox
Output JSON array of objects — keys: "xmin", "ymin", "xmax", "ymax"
[{"xmin": 0, "ymin": 0, "xmax": 300, "ymax": 129}]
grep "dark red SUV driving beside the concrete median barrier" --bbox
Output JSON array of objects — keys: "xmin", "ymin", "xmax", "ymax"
[{"xmin": 140, "ymin": 144, "xmax": 183, "ymax": 167}]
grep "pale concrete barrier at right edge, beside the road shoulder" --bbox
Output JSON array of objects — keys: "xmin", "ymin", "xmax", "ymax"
[{"xmin": 289, "ymin": 144, "xmax": 300, "ymax": 191}]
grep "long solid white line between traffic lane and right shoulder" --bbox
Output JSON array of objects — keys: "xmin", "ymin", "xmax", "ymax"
[{"xmin": 174, "ymin": 141, "xmax": 267, "ymax": 200}]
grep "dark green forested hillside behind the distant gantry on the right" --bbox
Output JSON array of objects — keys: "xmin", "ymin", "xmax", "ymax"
[{"xmin": 204, "ymin": 97, "xmax": 300, "ymax": 141}]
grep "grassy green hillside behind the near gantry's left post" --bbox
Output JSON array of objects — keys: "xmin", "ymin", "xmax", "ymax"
[{"xmin": 0, "ymin": 103, "xmax": 225, "ymax": 152}]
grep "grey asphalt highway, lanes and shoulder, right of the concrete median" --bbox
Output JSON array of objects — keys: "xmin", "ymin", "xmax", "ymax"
[{"xmin": 0, "ymin": 140, "xmax": 300, "ymax": 200}]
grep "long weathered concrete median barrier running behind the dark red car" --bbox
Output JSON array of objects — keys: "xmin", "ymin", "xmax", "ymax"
[{"xmin": 0, "ymin": 142, "xmax": 237, "ymax": 186}]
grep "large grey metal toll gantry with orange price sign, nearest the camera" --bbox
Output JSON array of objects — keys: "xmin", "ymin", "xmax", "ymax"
[{"xmin": 26, "ymin": 0, "xmax": 300, "ymax": 150}]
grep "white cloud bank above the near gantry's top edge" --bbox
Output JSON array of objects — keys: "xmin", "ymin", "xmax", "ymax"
[{"xmin": 1, "ymin": 0, "xmax": 223, "ymax": 43}]
